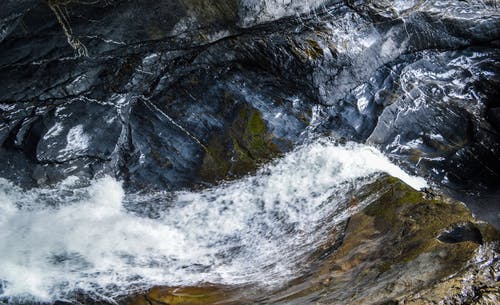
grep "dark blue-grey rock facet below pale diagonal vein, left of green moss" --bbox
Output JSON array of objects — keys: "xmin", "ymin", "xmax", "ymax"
[{"xmin": 125, "ymin": 100, "xmax": 203, "ymax": 188}]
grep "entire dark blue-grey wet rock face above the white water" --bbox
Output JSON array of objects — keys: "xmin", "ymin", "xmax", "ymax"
[{"xmin": 0, "ymin": 0, "xmax": 500, "ymax": 194}]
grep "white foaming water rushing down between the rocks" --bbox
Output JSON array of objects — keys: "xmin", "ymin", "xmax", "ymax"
[{"xmin": 0, "ymin": 140, "xmax": 425, "ymax": 301}]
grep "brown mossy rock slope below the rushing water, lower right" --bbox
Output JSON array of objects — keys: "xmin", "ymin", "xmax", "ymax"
[{"xmin": 123, "ymin": 176, "xmax": 500, "ymax": 305}]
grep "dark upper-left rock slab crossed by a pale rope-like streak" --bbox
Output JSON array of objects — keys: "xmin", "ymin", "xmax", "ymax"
[{"xmin": 0, "ymin": 0, "xmax": 237, "ymax": 65}]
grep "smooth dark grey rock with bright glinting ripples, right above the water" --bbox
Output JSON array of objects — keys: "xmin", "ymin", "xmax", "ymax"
[{"xmin": 367, "ymin": 50, "xmax": 500, "ymax": 188}]
